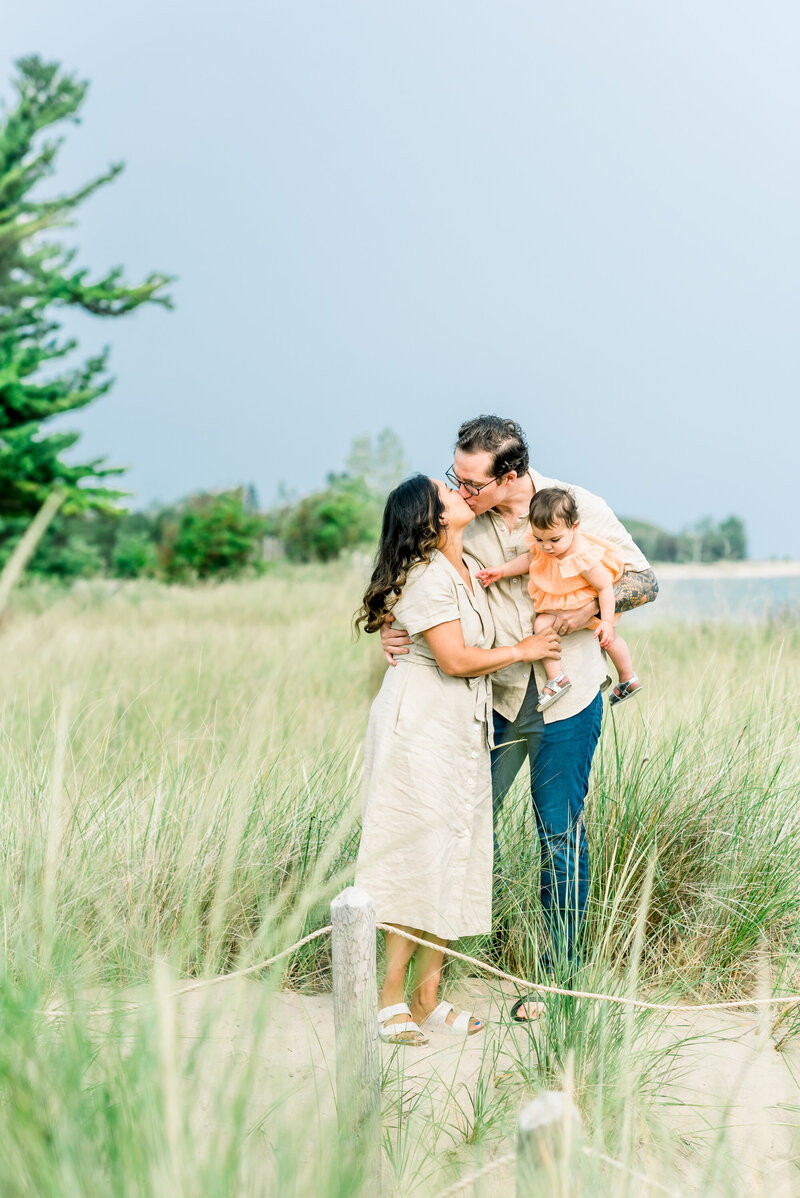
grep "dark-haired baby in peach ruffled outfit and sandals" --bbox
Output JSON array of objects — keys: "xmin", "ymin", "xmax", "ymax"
[{"xmin": 478, "ymin": 486, "xmax": 642, "ymax": 712}]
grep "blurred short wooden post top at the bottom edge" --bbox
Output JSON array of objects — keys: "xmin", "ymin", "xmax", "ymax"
[{"xmin": 516, "ymin": 1090, "xmax": 581, "ymax": 1198}]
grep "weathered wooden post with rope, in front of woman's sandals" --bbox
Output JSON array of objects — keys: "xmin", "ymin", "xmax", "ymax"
[{"xmin": 331, "ymin": 887, "xmax": 381, "ymax": 1192}]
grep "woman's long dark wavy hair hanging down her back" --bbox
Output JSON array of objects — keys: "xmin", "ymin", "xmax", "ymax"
[{"xmin": 353, "ymin": 474, "xmax": 444, "ymax": 635}]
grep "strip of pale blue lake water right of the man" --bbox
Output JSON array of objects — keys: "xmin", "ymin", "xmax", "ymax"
[{"xmin": 628, "ymin": 577, "xmax": 800, "ymax": 624}]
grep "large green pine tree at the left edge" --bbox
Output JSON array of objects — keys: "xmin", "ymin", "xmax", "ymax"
[{"xmin": 0, "ymin": 58, "xmax": 170, "ymax": 518}]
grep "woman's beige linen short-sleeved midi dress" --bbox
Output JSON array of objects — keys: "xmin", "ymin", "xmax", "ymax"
[{"xmin": 356, "ymin": 551, "xmax": 495, "ymax": 940}]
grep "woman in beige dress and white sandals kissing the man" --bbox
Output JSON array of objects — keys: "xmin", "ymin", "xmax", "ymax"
[{"xmin": 356, "ymin": 474, "xmax": 558, "ymax": 1045}]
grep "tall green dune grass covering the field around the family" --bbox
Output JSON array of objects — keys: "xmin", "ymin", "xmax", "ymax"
[{"xmin": 0, "ymin": 567, "xmax": 800, "ymax": 1194}]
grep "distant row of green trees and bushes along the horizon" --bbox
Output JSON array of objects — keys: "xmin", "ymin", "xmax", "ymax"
[{"xmin": 0, "ymin": 448, "xmax": 747, "ymax": 582}]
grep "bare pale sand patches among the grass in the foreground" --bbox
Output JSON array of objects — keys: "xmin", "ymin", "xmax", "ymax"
[{"xmin": 110, "ymin": 979, "xmax": 800, "ymax": 1198}]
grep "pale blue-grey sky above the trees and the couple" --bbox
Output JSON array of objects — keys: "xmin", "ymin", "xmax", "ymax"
[{"xmin": 2, "ymin": 0, "xmax": 800, "ymax": 557}]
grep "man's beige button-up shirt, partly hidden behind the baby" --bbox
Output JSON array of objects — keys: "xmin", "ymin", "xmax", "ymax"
[{"xmin": 463, "ymin": 470, "xmax": 649, "ymax": 724}]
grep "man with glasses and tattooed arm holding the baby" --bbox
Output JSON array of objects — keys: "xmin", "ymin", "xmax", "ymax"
[{"xmin": 381, "ymin": 416, "xmax": 659, "ymax": 1019}]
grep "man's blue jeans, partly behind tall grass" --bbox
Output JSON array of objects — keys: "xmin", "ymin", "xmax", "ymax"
[{"xmin": 492, "ymin": 673, "xmax": 602, "ymax": 974}]
